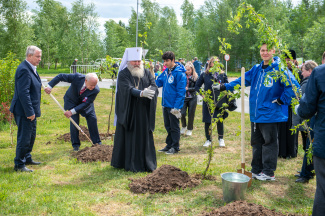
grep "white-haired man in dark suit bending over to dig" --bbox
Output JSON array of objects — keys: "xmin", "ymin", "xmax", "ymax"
[{"xmin": 44, "ymin": 73, "xmax": 102, "ymax": 151}]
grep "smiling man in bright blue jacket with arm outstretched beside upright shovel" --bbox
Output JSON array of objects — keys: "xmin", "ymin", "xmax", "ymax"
[{"xmin": 214, "ymin": 44, "xmax": 299, "ymax": 181}]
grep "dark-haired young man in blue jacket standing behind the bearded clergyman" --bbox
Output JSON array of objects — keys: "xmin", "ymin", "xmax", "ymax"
[{"xmin": 156, "ymin": 51, "xmax": 187, "ymax": 154}]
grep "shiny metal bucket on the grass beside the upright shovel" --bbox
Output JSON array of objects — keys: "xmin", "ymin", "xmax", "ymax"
[{"xmin": 221, "ymin": 172, "xmax": 250, "ymax": 203}]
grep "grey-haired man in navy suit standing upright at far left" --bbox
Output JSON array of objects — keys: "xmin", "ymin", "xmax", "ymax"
[{"xmin": 10, "ymin": 46, "xmax": 42, "ymax": 172}]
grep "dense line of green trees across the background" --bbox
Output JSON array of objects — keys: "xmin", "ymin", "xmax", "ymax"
[{"xmin": 0, "ymin": 0, "xmax": 325, "ymax": 70}]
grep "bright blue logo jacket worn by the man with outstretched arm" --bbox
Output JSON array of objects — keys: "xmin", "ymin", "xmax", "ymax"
[{"xmin": 225, "ymin": 57, "xmax": 300, "ymax": 123}]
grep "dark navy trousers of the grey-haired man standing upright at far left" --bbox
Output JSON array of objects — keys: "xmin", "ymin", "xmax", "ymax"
[{"xmin": 14, "ymin": 115, "xmax": 37, "ymax": 168}]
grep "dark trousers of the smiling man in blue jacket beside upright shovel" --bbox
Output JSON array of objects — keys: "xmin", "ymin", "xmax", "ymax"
[{"xmin": 251, "ymin": 122, "xmax": 279, "ymax": 176}]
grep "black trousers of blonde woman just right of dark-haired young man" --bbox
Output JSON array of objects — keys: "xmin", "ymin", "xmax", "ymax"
[{"xmin": 181, "ymin": 96, "xmax": 197, "ymax": 130}]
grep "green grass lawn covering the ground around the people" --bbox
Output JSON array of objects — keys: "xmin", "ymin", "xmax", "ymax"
[{"xmin": 0, "ymin": 87, "xmax": 316, "ymax": 216}]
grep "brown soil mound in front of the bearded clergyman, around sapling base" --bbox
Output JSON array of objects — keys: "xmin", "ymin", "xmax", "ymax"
[{"xmin": 129, "ymin": 165, "xmax": 201, "ymax": 194}]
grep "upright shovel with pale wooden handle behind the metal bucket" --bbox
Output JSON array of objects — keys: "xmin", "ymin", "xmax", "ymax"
[{"xmin": 237, "ymin": 67, "xmax": 252, "ymax": 187}]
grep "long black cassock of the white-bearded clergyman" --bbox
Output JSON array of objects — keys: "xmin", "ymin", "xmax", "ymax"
[{"xmin": 111, "ymin": 68, "xmax": 158, "ymax": 172}]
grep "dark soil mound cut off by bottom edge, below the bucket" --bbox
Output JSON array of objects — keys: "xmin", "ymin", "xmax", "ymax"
[{"xmin": 202, "ymin": 201, "xmax": 293, "ymax": 216}]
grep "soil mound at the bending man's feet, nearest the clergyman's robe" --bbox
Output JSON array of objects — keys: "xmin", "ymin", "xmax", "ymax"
[{"xmin": 76, "ymin": 144, "xmax": 113, "ymax": 163}]
